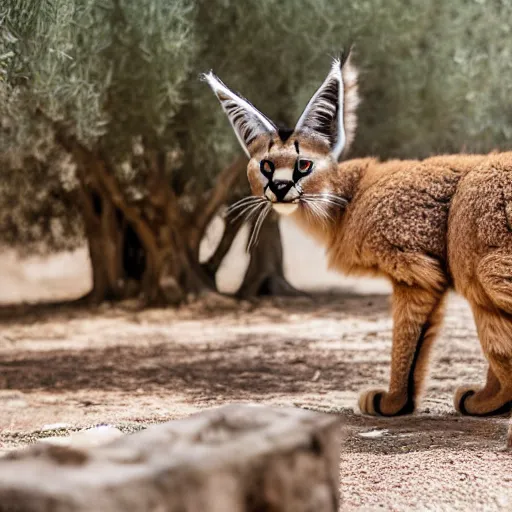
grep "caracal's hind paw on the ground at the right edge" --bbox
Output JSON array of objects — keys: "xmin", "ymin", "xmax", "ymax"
[{"xmin": 453, "ymin": 386, "xmax": 512, "ymax": 416}]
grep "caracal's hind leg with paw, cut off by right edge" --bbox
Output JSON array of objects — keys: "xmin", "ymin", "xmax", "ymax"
[{"xmin": 454, "ymin": 251, "xmax": 512, "ymax": 416}]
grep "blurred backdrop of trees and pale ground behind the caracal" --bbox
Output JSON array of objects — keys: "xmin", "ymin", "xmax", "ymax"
[{"xmin": 0, "ymin": 0, "xmax": 512, "ymax": 305}]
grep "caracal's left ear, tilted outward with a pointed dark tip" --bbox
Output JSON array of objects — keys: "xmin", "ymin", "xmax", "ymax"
[{"xmin": 203, "ymin": 72, "xmax": 277, "ymax": 158}]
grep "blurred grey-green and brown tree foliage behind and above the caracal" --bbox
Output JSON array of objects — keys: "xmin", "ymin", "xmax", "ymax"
[{"xmin": 0, "ymin": 0, "xmax": 512, "ymax": 254}]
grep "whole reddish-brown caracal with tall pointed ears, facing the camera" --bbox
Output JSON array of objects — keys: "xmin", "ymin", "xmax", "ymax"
[{"xmin": 205, "ymin": 51, "xmax": 512, "ymax": 436}]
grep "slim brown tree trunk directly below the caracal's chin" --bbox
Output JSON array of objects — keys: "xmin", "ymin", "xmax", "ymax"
[{"xmin": 237, "ymin": 212, "xmax": 302, "ymax": 299}]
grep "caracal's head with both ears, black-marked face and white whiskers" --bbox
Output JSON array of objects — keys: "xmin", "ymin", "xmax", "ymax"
[{"xmin": 204, "ymin": 50, "xmax": 358, "ymax": 232}]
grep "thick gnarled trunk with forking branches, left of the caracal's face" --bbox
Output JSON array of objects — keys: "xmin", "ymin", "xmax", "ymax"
[{"xmin": 46, "ymin": 117, "xmax": 218, "ymax": 305}]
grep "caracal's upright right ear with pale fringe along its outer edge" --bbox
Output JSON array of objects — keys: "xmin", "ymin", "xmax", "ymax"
[{"xmin": 295, "ymin": 51, "xmax": 359, "ymax": 160}]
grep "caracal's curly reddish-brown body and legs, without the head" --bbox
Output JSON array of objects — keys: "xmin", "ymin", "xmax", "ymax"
[{"xmin": 304, "ymin": 153, "xmax": 512, "ymax": 416}]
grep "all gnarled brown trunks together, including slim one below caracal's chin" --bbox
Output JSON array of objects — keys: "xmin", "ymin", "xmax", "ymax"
[{"xmin": 53, "ymin": 114, "xmax": 298, "ymax": 305}]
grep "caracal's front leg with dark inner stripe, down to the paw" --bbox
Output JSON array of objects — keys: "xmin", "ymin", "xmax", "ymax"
[{"xmin": 359, "ymin": 283, "xmax": 445, "ymax": 416}]
